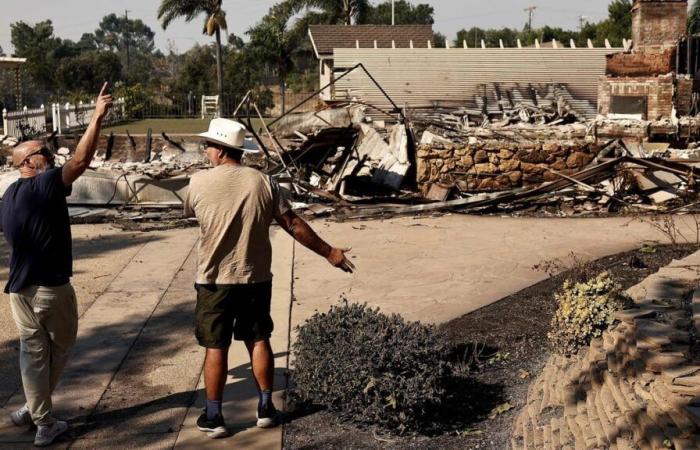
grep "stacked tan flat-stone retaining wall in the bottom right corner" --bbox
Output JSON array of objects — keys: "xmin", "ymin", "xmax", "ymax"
[{"xmin": 511, "ymin": 253, "xmax": 700, "ymax": 450}]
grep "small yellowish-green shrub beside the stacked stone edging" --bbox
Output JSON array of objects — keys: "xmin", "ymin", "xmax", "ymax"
[{"xmin": 548, "ymin": 272, "xmax": 629, "ymax": 355}]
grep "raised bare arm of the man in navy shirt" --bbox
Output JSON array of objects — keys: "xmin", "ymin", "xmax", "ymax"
[{"xmin": 63, "ymin": 83, "xmax": 112, "ymax": 186}]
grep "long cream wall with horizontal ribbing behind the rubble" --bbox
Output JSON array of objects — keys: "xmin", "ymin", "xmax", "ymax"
[{"xmin": 334, "ymin": 48, "xmax": 621, "ymax": 116}]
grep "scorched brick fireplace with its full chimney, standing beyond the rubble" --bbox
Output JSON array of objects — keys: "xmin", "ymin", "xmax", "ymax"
[{"xmin": 598, "ymin": 0, "xmax": 698, "ymax": 121}]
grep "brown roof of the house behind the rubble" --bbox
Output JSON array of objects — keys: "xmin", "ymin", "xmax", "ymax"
[{"xmin": 309, "ymin": 25, "xmax": 433, "ymax": 58}]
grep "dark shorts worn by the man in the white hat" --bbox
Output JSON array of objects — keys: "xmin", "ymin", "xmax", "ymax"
[{"xmin": 195, "ymin": 281, "xmax": 274, "ymax": 349}]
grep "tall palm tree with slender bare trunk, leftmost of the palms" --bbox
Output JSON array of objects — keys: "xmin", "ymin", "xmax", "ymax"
[{"xmin": 158, "ymin": 0, "xmax": 228, "ymax": 116}]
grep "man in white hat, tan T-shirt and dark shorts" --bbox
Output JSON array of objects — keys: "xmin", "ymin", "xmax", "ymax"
[{"xmin": 185, "ymin": 119, "xmax": 354, "ymax": 438}]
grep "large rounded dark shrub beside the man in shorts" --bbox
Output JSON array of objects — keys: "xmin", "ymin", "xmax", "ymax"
[{"xmin": 293, "ymin": 301, "xmax": 451, "ymax": 433}]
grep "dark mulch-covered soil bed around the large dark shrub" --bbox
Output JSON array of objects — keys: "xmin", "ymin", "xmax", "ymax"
[{"xmin": 284, "ymin": 246, "xmax": 696, "ymax": 450}]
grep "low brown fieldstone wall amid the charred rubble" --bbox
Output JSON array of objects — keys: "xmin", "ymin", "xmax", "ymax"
[{"xmin": 416, "ymin": 138, "xmax": 599, "ymax": 191}]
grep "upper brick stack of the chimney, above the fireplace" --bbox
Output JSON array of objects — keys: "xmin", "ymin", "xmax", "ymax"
[{"xmin": 632, "ymin": 0, "xmax": 688, "ymax": 53}]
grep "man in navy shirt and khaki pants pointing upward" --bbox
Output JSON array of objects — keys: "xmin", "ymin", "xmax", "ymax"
[{"xmin": 0, "ymin": 83, "xmax": 112, "ymax": 446}]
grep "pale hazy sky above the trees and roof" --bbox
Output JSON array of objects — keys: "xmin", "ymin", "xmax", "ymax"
[{"xmin": 0, "ymin": 0, "xmax": 610, "ymax": 53}]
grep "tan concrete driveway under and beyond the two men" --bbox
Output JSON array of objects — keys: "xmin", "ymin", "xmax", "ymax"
[{"xmin": 0, "ymin": 216, "xmax": 688, "ymax": 450}]
